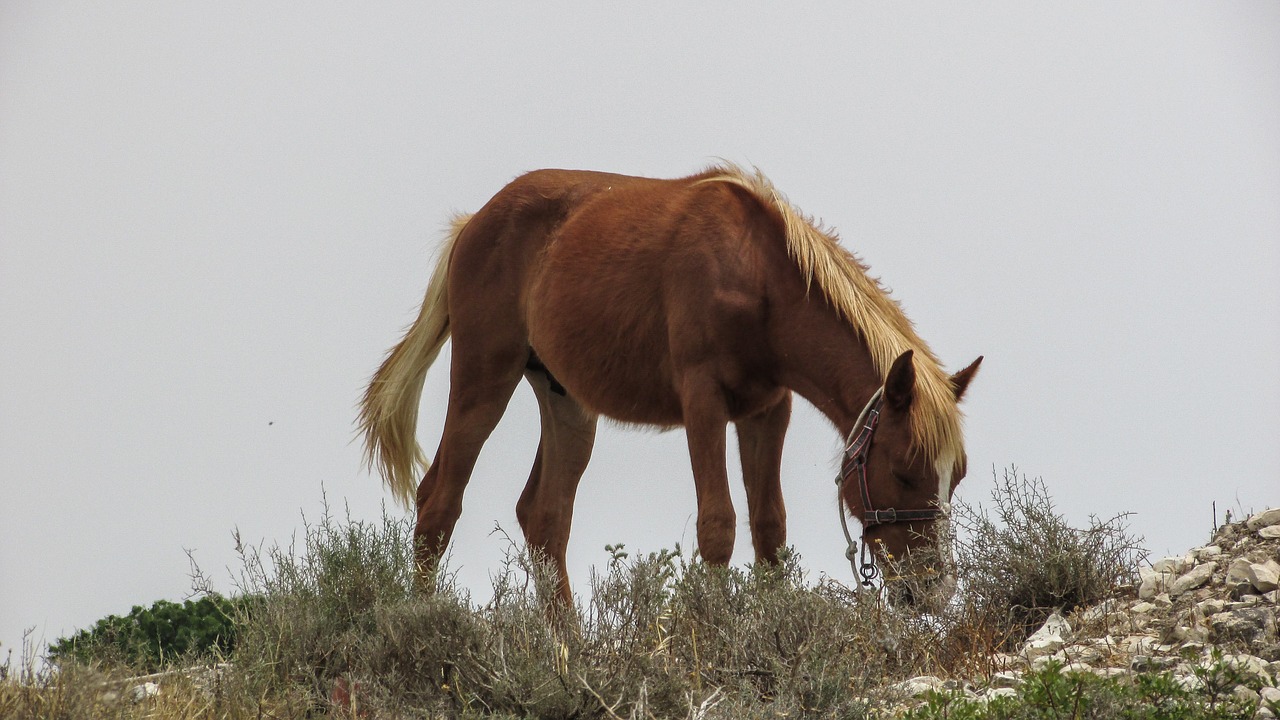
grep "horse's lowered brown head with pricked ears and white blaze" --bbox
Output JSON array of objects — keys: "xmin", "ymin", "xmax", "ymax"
[{"xmin": 840, "ymin": 351, "xmax": 982, "ymax": 610}]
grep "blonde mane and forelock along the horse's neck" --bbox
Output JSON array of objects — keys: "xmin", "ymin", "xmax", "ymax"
[{"xmin": 701, "ymin": 163, "xmax": 964, "ymax": 462}]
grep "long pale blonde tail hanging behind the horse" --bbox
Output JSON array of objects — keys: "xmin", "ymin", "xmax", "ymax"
[{"xmin": 360, "ymin": 215, "xmax": 471, "ymax": 507}]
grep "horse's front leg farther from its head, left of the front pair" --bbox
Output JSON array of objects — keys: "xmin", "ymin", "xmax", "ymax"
[{"xmin": 682, "ymin": 378, "xmax": 737, "ymax": 565}]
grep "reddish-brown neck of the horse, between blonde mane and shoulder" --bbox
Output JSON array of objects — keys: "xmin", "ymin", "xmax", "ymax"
[{"xmin": 777, "ymin": 291, "xmax": 882, "ymax": 434}]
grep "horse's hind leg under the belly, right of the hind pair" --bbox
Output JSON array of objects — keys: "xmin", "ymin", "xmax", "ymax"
[{"xmin": 516, "ymin": 370, "xmax": 596, "ymax": 607}]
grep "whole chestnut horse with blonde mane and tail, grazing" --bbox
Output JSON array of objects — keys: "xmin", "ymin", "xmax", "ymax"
[{"xmin": 360, "ymin": 165, "xmax": 982, "ymax": 602}]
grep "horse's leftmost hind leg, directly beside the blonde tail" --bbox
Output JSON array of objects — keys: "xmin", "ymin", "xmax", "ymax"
[{"xmin": 413, "ymin": 340, "xmax": 529, "ymax": 574}]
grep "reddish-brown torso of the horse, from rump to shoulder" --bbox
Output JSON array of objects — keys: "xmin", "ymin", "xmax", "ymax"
[{"xmin": 451, "ymin": 170, "xmax": 777, "ymax": 425}]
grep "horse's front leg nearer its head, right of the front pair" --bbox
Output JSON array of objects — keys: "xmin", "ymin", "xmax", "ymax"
[{"xmin": 735, "ymin": 392, "xmax": 791, "ymax": 562}]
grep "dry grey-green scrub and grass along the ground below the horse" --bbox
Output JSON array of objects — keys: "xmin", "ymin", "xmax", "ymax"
[{"xmin": 0, "ymin": 470, "xmax": 1269, "ymax": 720}]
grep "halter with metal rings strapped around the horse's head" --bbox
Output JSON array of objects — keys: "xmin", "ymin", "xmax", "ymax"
[{"xmin": 836, "ymin": 387, "xmax": 942, "ymax": 588}]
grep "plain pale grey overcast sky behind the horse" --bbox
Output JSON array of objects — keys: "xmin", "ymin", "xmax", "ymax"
[{"xmin": 0, "ymin": 0, "xmax": 1280, "ymax": 661}]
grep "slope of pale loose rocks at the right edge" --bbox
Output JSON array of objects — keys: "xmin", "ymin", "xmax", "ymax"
[{"xmin": 895, "ymin": 509, "xmax": 1280, "ymax": 719}]
